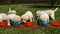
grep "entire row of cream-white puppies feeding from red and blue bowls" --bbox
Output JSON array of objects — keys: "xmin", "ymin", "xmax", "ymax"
[{"xmin": 0, "ymin": 8, "xmax": 58, "ymax": 25}]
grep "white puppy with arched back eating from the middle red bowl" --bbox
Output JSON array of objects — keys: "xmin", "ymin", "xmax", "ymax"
[{"xmin": 21, "ymin": 11, "xmax": 34, "ymax": 22}]
